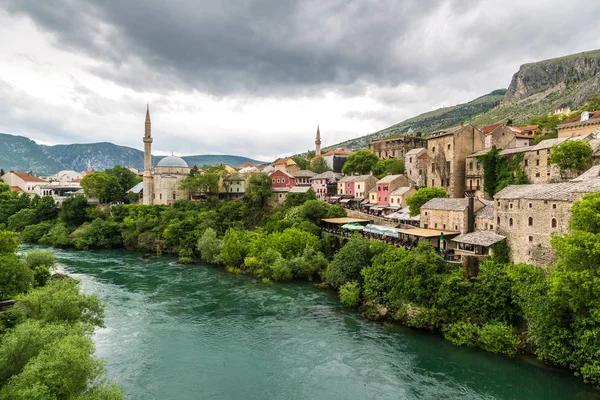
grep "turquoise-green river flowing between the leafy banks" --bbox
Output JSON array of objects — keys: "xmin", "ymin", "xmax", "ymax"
[{"xmin": 36, "ymin": 248, "xmax": 597, "ymax": 400}]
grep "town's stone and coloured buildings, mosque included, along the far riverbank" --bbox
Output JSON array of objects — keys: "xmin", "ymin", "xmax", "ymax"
[{"xmin": 7, "ymin": 109, "xmax": 600, "ymax": 265}]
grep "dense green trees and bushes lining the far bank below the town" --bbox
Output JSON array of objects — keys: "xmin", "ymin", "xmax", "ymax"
[{"xmin": 0, "ymin": 174, "xmax": 600, "ymax": 385}]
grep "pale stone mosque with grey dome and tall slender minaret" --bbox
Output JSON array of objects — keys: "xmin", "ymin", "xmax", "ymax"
[{"xmin": 140, "ymin": 106, "xmax": 191, "ymax": 205}]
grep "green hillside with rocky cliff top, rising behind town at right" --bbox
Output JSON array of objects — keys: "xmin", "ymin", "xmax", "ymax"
[{"xmin": 327, "ymin": 50, "xmax": 600, "ymax": 150}]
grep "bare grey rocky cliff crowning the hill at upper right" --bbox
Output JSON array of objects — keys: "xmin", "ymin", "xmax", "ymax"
[{"xmin": 504, "ymin": 50, "xmax": 600, "ymax": 104}]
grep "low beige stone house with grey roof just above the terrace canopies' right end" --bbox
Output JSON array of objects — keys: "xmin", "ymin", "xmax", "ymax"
[{"xmin": 421, "ymin": 198, "xmax": 485, "ymax": 233}]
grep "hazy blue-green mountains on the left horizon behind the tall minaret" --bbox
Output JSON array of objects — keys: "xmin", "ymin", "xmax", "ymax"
[{"xmin": 0, "ymin": 133, "xmax": 264, "ymax": 175}]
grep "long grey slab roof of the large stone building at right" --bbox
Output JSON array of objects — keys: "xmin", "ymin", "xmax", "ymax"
[{"xmin": 494, "ymin": 178, "xmax": 600, "ymax": 201}]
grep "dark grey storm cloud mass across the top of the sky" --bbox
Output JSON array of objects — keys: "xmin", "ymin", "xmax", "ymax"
[{"xmin": 3, "ymin": 0, "xmax": 463, "ymax": 94}]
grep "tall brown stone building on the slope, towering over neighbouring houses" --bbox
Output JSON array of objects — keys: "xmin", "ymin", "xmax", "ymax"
[{"xmin": 427, "ymin": 125, "xmax": 485, "ymax": 198}]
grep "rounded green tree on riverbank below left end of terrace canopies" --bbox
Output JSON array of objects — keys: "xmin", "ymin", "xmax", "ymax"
[{"xmin": 325, "ymin": 235, "xmax": 371, "ymax": 288}]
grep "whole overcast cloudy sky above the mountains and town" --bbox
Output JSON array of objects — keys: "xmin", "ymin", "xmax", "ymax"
[{"xmin": 0, "ymin": 0, "xmax": 600, "ymax": 160}]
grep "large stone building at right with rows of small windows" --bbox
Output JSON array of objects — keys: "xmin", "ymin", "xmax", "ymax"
[{"xmin": 494, "ymin": 178, "xmax": 600, "ymax": 265}]
